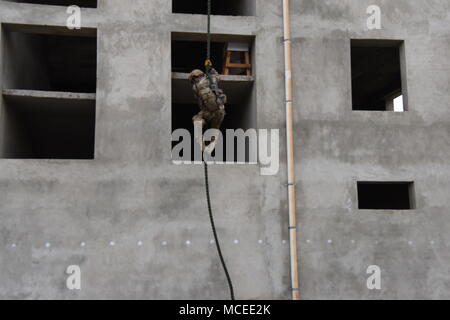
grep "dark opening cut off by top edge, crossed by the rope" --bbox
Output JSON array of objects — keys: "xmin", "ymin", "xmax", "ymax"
[{"xmin": 172, "ymin": 0, "xmax": 256, "ymax": 16}]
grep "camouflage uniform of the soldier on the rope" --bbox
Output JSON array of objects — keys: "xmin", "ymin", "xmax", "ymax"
[{"xmin": 189, "ymin": 69, "xmax": 227, "ymax": 129}]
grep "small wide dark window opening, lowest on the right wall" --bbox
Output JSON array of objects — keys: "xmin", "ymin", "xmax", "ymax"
[{"xmin": 358, "ymin": 182, "xmax": 414, "ymax": 210}]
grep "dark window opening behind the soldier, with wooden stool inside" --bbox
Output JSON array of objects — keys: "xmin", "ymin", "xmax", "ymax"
[{"xmin": 172, "ymin": 34, "xmax": 256, "ymax": 163}]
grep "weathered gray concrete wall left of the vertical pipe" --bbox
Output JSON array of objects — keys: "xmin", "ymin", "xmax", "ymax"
[{"xmin": 0, "ymin": 0, "xmax": 290, "ymax": 299}]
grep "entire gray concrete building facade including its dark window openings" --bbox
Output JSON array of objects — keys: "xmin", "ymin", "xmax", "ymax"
[{"xmin": 0, "ymin": 0, "xmax": 450, "ymax": 299}]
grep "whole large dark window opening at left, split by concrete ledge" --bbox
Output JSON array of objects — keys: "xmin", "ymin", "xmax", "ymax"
[{"xmin": 0, "ymin": 24, "xmax": 97, "ymax": 159}]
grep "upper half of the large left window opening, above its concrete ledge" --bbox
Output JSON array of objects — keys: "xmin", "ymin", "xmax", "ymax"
[{"xmin": 3, "ymin": 25, "xmax": 97, "ymax": 93}]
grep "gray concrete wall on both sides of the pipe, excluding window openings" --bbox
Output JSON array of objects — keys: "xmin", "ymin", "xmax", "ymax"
[{"xmin": 0, "ymin": 0, "xmax": 450, "ymax": 299}]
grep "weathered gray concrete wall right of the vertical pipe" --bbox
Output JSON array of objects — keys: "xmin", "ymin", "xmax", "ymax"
[{"xmin": 292, "ymin": 0, "xmax": 450, "ymax": 299}]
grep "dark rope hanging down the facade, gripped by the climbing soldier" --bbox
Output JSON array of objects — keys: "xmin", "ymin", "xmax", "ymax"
[{"xmin": 203, "ymin": 0, "xmax": 234, "ymax": 300}]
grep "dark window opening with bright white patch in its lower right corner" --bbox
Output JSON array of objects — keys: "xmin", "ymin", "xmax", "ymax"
[{"xmin": 351, "ymin": 40, "xmax": 406, "ymax": 112}]
